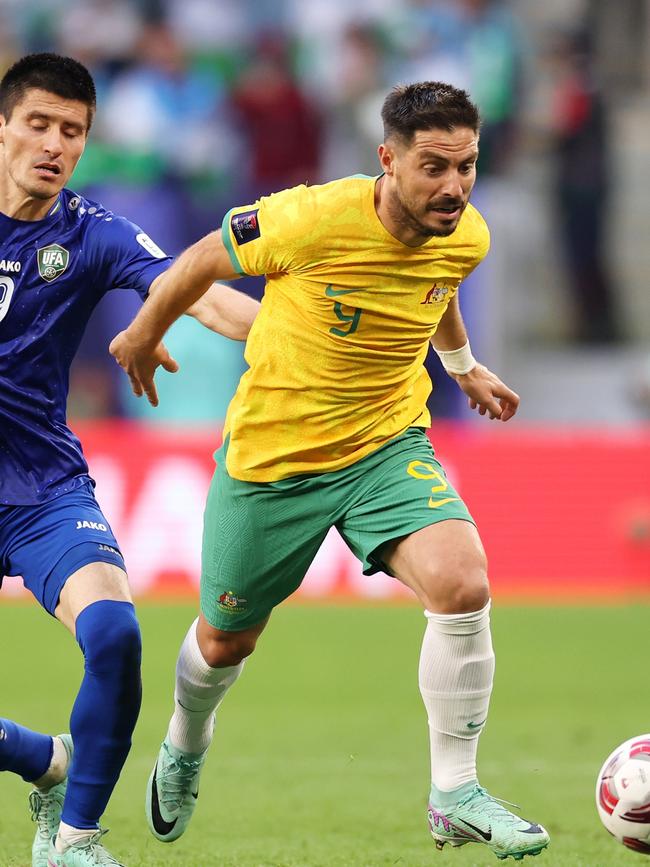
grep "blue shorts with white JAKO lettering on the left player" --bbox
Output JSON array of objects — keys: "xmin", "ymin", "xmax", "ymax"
[{"xmin": 0, "ymin": 481, "xmax": 125, "ymax": 615}]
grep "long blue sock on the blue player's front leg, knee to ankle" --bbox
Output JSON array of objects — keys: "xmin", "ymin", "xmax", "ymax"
[{"xmin": 61, "ymin": 600, "xmax": 142, "ymax": 828}]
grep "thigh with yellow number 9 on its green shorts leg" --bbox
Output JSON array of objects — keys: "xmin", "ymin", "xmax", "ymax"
[{"xmin": 337, "ymin": 428, "xmax": 482, "ymax": 597}]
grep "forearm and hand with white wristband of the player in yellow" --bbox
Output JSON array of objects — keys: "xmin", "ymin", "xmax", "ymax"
[{"xmin": 431, "ymin": 295, "xmax": 520, "ymax": 421}]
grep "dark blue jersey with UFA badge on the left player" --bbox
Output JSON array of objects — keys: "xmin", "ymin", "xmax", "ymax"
[{"xmin": 0, "ymin": 190, "xmax": 170, "ymax": 505}]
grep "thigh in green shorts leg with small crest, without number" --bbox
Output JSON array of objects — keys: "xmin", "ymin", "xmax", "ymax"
[{"xmin": 201, "ymin": 461, "xmax": 333, "ymax": 631}]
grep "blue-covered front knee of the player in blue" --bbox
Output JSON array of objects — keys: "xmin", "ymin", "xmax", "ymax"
[{"xmin": 76, "ymin": 600, "xmax": 142, "ymax": 680}]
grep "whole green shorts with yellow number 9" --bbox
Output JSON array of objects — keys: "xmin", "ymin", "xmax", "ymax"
[{"xmin": 201, "ymin": 428, "xmax": 473, "ymax": 630}]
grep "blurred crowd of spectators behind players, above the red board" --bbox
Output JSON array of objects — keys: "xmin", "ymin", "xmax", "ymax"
[{"xmin": 0, "ymin": 0, "xmax": 618, "ymax": 421}]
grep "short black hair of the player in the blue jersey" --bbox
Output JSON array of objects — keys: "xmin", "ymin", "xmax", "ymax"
[{"xmin": 0, "ymin": 52, "xmax": 97, "ymax": 129}]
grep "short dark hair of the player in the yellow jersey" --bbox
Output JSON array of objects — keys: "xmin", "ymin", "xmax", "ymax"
[{"xmin": 381, "ymin": 81, "xmax": 481, "ymax": 143}]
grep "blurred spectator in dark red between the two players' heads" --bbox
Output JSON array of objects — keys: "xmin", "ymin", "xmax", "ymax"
[{"xmin": 232, "ymin": 33, "xmax": 321, "ymax": 198}]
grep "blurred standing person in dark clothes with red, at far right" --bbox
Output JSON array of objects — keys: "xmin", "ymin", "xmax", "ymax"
[{"xmin": 551, "ymin": 34, "xmax": 620, "ymax": 343}]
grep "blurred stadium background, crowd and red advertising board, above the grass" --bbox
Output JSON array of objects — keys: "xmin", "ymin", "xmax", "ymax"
[{"xmin": 0, "ymin": 0, "xmax": 650, "ymax": 601}]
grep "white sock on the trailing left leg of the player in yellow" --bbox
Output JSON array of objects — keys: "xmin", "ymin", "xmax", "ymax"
[{"xmin": 167, "ymin": 618, "xmax": 244, "ymax": 753}]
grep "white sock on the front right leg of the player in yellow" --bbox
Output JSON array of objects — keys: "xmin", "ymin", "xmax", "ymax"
[{"xmin": 419, "ymin": 602, "xmax": 494, "ymax": 792}]
